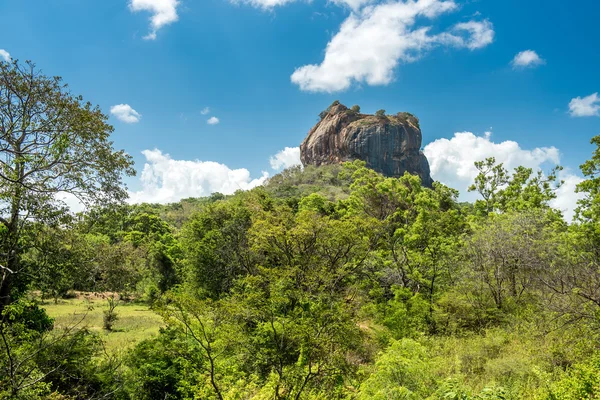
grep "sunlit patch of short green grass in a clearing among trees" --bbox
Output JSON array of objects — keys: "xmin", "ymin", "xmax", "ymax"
[{"xmin": 42, "ymin": 299, "xmax": 163, "ymax": 352}]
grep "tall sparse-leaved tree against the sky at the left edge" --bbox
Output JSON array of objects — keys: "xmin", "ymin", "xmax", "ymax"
[{"xmin": 0, "ymin": 60, "xmax": 135, "ymax": 308}]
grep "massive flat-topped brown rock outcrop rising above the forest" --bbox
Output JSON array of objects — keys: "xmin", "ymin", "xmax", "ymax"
[{"xmin": 300, "ymin": 103, "xmax": 433, "ymax": 186}]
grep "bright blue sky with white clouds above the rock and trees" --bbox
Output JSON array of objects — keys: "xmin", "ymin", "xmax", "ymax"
[{"xmin": 0, "ymin": 0, "xmax": 600, "ymax": 217}]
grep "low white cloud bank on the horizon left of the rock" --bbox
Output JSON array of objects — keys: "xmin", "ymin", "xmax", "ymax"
[{"xmin": 129, "ymin": 149, "xmax": 269, "ymax": 203}]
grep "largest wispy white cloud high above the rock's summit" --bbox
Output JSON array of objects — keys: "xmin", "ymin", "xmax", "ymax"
[{"xmin": 291, "ymin": 0, "xmax": 494, "ymax": 92}]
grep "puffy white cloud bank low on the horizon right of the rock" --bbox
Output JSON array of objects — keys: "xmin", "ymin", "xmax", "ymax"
[{"xmin": 423, "ymin": 132, "xmax": 581, "ymax": 220}]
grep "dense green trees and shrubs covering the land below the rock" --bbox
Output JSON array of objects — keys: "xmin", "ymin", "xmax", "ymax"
[{"xmin": 0, "ymin": 64, "xmax": 600, "ymax": 399}]
